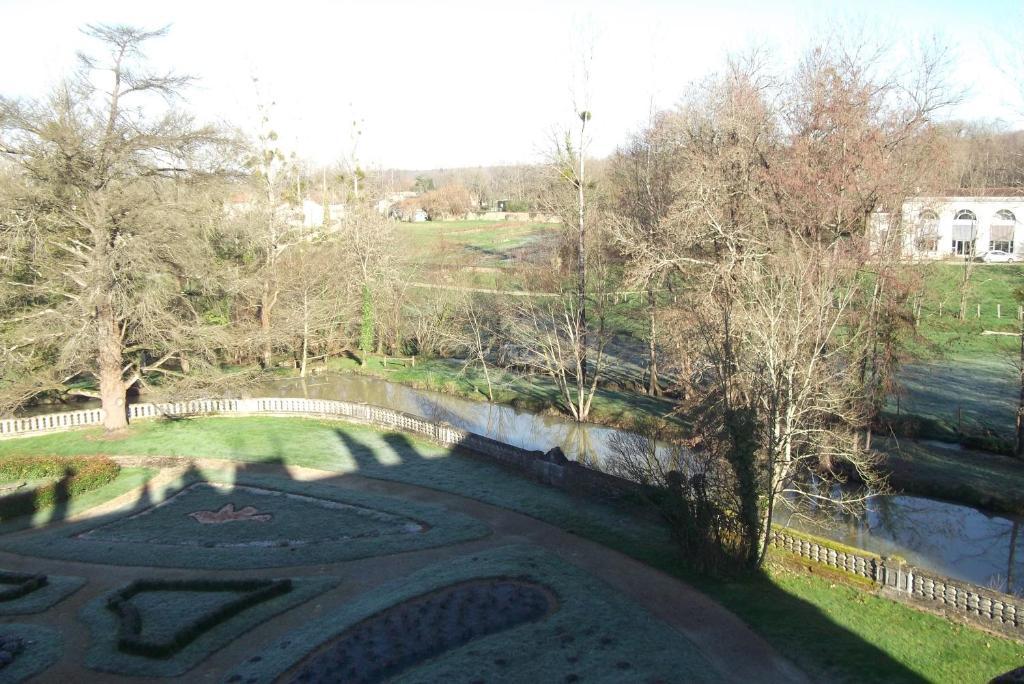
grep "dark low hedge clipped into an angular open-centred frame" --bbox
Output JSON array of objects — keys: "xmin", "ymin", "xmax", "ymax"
[{"xmin": 106, "ymin": 579, "xmax": 292, "ymax": 658}]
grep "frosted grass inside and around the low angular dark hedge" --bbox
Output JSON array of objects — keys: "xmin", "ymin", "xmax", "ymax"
[{"xmin": 79, "ymin": 578, "xmax": 337, "ymax": 677}]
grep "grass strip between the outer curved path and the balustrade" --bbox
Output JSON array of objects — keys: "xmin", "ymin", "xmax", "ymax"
[{"xmin": 0, "ymin": 418, "xmax": 1024, "ymax": 682}]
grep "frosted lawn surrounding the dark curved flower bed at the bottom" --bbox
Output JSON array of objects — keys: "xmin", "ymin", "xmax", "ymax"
[{"xmin": 228, "ymin": 547, "xmax": 720, "ymax": 682}]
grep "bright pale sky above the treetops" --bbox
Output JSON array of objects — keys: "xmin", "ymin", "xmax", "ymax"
[{"xmin": 0, "ymin": 0, "xmax": 1024, "ymax": 169}]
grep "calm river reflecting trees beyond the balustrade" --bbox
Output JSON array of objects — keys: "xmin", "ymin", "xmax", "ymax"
[{"xmin": 18, "ymin": 374, "xmax": 1024, "ymax": 593}]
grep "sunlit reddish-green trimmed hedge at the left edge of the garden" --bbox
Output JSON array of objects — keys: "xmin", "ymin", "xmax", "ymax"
[{"xmin": 0, "ymin": 456, "xmax": 121, "ymax": 522}]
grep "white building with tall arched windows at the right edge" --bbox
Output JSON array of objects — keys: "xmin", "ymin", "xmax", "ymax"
[{"xmin": 903, "ymin": 190, "xmax": 1024, "ymax": 259}]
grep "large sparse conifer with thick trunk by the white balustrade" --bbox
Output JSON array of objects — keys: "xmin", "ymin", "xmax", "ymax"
[{"xmin": 0, "ymin": 25, "xmax": 233, "ymax": 430}]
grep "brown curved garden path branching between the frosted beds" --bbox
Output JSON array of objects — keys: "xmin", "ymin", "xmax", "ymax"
[{"xmin": 0, "ymin": 459, "xmax": 809, "ymax": 682}]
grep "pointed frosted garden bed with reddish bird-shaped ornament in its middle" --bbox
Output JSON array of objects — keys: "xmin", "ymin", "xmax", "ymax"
[{"xmin": 0, "ymin": 471, "xmax": 489, "ymax": 569}]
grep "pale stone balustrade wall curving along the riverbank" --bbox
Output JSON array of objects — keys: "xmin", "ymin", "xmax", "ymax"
[{"xmin": 0, "ymin": 397, "xmax": 1024, "ymax": 639}]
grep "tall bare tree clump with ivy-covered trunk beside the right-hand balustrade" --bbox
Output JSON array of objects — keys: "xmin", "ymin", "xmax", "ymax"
[{"xmin": 606, "ymin": 37, "xmax": 943, "ymax": 566}]
